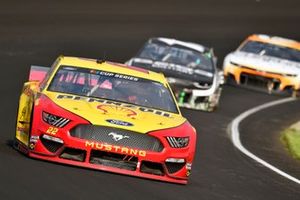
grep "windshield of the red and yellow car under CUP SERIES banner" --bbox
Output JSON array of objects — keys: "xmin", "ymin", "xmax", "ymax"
[{"xmin": 48, "ymin": 66, "xmax": 178, "ymax": 113}]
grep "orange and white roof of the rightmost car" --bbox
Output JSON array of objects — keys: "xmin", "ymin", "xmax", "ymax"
[{"xmin": 247, "ymin": 34, "xmax": 300, "ymax": 50}]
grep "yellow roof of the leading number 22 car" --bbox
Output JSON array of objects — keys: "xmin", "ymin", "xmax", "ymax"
[{"xmin": 58, "ymin": 56, "xmax": 167, "ymax": 84}]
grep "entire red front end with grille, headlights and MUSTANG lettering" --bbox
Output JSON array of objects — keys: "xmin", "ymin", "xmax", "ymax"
[{"xmin": 16, "ymin": 95, "xmax": 196, "ymax": 184}]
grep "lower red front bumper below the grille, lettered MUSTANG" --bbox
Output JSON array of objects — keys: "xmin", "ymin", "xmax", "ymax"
[{"xmin": 28, "ymin": 125, "xmax": 194, "ymax": 184}]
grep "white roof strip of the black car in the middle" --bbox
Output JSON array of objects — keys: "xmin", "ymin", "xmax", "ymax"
[{"xmin": 151, "ymin": 37, "xmax": 208, "ymax": 53}]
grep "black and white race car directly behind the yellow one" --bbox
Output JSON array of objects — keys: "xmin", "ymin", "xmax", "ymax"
[{"xmin": 126, "ymin": 37, "xmax": 224, "ymax": 111}]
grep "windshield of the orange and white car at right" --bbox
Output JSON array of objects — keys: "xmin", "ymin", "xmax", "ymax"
[{"xmin": 240, "ymin": 41, "xmax": 300, "ymax": 62}]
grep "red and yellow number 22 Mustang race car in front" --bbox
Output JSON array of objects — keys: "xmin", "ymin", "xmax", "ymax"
[{"xmin": 14, "ymin": 56, "xmax": 196, "ymax": 184}]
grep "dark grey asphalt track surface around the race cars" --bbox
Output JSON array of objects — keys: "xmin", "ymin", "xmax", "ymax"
[{"xmin": 0, "ymin": 0, "xmax": 300, "ymax": 200}]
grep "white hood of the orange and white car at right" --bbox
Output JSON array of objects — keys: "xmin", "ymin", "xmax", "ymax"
[{"xmin": 228, "ymin": 51, "xmax": 300, "ymax": 75}]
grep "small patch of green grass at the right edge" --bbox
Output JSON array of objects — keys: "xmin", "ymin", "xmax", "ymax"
[{"xmin": 282, "ymin": 128, "xmax": 300, "ymax": 160}]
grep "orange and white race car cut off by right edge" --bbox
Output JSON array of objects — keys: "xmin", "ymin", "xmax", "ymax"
[{"xmin": 223, "ymin": 34, "xmax": 300, "ymax": 96}]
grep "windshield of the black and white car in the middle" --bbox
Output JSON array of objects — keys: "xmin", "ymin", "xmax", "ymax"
[{"xmin": 137, "ymin": 42, "xmax": 214, "ymax": 72}]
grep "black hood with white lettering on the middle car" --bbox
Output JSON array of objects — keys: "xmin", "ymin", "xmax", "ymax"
[{"xmin": 129, "ymin": 58, "xmax": 214, "ymax": 84}]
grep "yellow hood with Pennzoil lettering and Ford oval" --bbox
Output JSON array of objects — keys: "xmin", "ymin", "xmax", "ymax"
[{"xmin": 44, "ymin": 92, "xmax": 186, "ymax": 133}]
